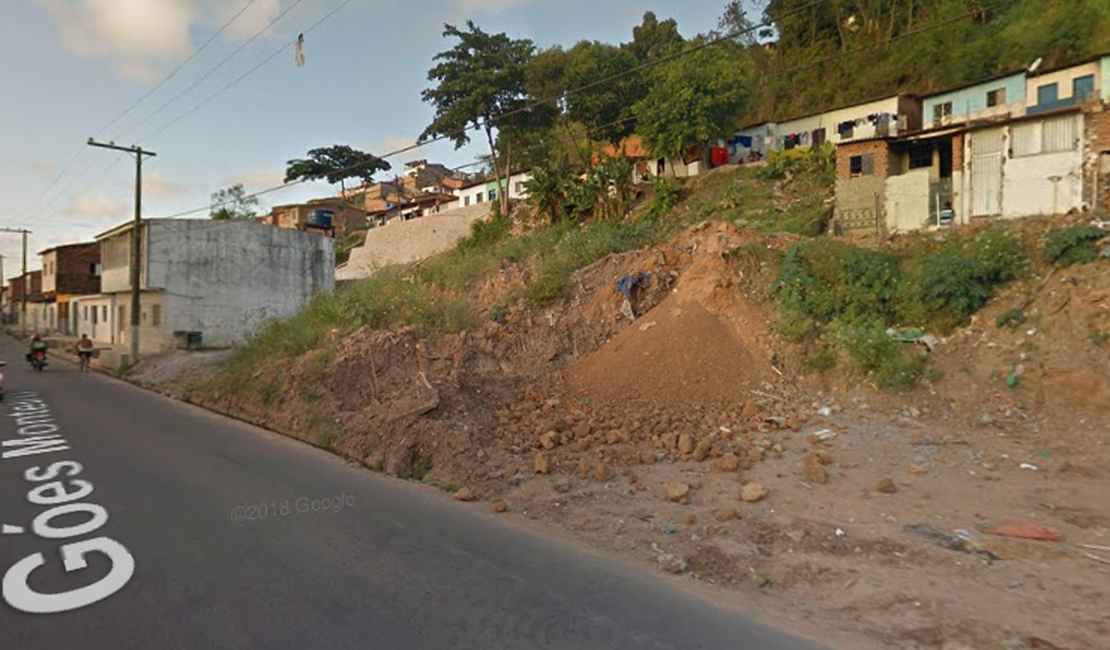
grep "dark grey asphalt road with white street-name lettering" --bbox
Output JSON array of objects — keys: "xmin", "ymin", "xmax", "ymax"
[{"xmin": 0, "ymin": 337, "xmax": 830, "ymax": 650}]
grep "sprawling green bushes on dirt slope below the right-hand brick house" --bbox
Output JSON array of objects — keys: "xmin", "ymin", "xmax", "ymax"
[{"xmin": 773, "ymin": 227, "xmax": 1027, "ymax": 387}]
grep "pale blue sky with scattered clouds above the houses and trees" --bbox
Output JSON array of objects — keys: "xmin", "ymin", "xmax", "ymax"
[{"xmin": 0, "ymin": 0, "xmax": 726, "ymax": 272}]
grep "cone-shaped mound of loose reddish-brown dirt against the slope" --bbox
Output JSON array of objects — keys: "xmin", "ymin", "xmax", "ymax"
[{"xmin": 567, "ymin": 295, "xmax": 766, "ymax": 408}]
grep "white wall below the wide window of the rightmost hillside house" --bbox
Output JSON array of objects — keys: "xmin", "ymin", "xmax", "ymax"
[{"xmin": 1002, "ymin": 149, "xmax": 1083, "ymax": 219}]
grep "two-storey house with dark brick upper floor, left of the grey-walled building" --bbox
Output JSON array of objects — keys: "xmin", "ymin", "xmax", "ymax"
[{"xmin": 40, "ymin": 242, "xmax": 100, "ymax": 336}]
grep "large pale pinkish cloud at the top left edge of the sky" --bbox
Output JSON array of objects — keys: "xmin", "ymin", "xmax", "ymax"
[{"xmin": 38, "ymin": 0, "xmax": 196, "ymax": 80}]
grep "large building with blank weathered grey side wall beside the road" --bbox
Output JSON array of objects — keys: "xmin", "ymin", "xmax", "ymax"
[{"xmin": 95, "ymin": 219, "xmax": 335, "ymax": 363}]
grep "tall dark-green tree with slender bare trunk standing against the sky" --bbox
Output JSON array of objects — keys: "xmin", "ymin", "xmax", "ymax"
[{"xmin": 420, "ymin": 21, "xmax": 536, "ymax": 212}]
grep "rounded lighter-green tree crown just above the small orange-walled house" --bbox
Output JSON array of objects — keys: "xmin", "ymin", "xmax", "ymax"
[{"xmin": 633, "ymin": 41, "xmax": 749, "ymax": 159}]
